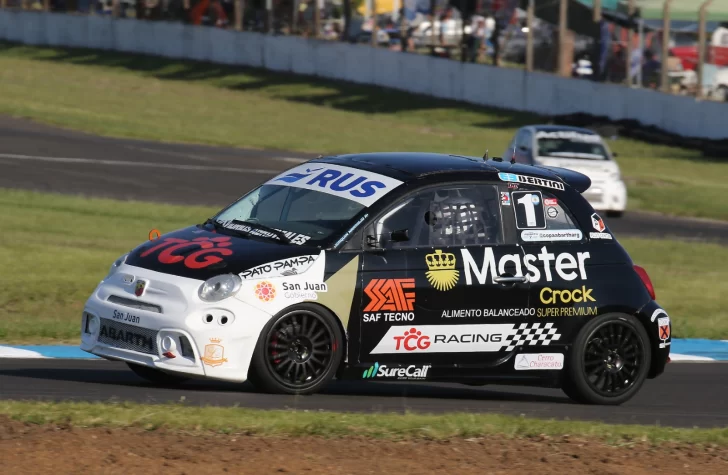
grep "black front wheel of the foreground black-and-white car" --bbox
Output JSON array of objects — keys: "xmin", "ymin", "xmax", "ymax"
[{"xmin": 248, "ymin": 303, "xmax": 344, "ymax": 395}]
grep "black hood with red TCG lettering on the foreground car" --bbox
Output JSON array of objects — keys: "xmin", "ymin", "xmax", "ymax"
[{"xmin": 126, "ymin": 226, "xmax": 321, "ymax": 280}]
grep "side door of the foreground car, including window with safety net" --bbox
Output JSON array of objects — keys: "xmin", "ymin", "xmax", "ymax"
[{"xmin": 359, "ymin": 183, "xmax": 530, "ymax": 365}]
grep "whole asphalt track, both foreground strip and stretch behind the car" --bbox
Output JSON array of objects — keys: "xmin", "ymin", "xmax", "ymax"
[{"xmin": 0, "ymin": 117, "xmax": 728, "ymax": 427}]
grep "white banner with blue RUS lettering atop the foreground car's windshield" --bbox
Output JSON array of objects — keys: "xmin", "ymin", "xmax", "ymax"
[{"xmin": 267, "ymin": 163, "xmax": 402, "ymax": 206}]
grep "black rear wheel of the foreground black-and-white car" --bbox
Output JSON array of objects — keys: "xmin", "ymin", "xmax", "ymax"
[{"xmin": 562, "ymin": 313, "xmax": 652, "ymax": 406}]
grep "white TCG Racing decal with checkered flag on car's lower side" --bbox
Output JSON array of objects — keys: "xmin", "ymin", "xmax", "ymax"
[{"xmin": 370, "ymin": 322, "xmax": 561, "ymax": 354}]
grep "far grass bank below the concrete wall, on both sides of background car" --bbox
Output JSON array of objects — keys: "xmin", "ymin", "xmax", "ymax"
[{"xmin": 0, "ymin": 43, "xmax": 728, "ymax": 220}]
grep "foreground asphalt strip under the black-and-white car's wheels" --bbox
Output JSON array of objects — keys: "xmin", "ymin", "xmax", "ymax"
[{"xmin": 0, "ymin": 359, "xmax": 728, "ymax": 427}]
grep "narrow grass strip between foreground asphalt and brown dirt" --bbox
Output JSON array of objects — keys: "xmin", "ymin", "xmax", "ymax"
[{"xmin": 0, "ymin": 401, "xmax": 728, "ymax": 446}]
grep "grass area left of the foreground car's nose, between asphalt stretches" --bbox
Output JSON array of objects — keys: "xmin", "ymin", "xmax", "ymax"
[{"xmin": 0, "ymin": 189, "xmax": 212, "ymax": 343}]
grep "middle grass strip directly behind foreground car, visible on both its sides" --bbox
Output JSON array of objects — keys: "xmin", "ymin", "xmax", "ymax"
[{"xmin": 0, "ymin": 189, "xmax": 728, "ymax": 344}]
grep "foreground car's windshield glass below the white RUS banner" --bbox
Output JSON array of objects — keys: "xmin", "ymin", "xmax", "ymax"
[{"xmin": 215, "ymin": 185, "xmax": 364, "ymax": 241}]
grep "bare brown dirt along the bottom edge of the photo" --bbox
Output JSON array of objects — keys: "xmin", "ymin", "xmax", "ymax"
[{"xmin": 0, "ymin": 417, "xmax": 728, "ymax": 475}]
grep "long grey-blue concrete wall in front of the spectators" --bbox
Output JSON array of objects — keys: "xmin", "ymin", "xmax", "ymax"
[{"xmin": 0, "ymin": 10, "xmax": 728, "ymax": 140}]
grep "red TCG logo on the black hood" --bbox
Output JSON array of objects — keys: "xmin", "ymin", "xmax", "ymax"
[{"xmin": 141, "ymin": 236, "xmax": 233, "ymax": 269}]
